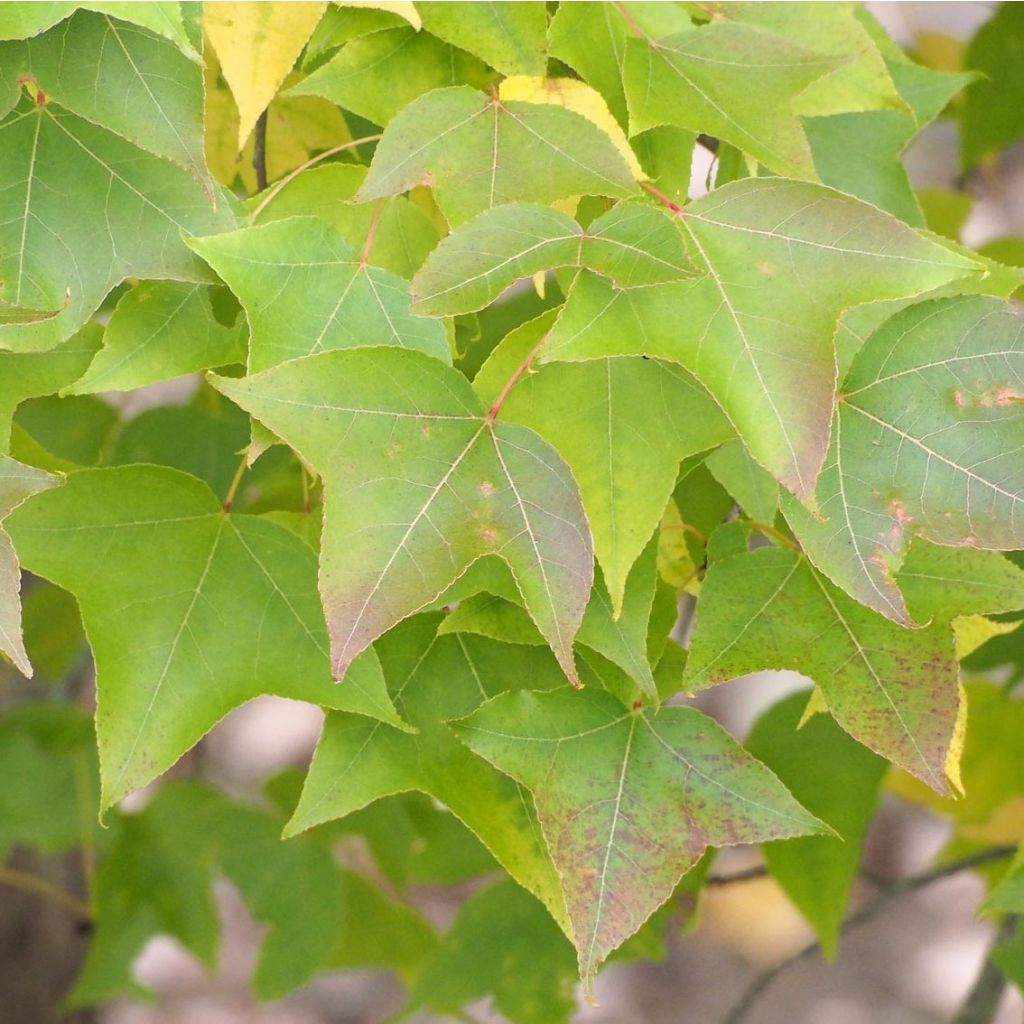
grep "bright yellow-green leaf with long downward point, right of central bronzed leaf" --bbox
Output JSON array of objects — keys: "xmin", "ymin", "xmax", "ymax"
[{"xmin": 502, "ymin": 356, "xmax": 732, "ymax": 615}]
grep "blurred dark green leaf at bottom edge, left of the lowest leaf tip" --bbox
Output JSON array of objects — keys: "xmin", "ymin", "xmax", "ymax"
[{"xmin": 409, "ymin": 882, "xmax": 575, "ymax": 1024}]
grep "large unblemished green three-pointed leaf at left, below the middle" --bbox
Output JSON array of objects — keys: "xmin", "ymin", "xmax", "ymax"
[{"xmin": 7, "ymin": 466, "xmax": 402, "ymax": 808}]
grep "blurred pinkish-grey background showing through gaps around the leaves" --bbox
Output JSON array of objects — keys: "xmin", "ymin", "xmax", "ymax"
[{"xmin": 0, "ymin": 2, "xmax": 1024, "ymax": 1024}]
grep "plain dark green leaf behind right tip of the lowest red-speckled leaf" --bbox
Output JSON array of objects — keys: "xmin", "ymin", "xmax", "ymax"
[{"xmin": 746, "ymin": 691, "xmax": 888, "ymax": 958}]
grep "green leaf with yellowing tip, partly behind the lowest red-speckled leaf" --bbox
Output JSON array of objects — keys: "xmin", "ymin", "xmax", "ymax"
[{"xmin": 285, "ymin": 613, "xmax": 568, "ymax": 930}]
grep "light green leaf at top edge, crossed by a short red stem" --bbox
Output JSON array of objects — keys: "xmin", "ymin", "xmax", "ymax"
[{"xmin": 549, "ymin": 3, "xmax": 691, "ymax": 128}]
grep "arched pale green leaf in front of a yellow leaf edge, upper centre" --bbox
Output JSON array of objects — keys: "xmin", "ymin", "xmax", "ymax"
[{"xmin": 356, "ymin": 86, "xmax": 636, "ymax": 225}]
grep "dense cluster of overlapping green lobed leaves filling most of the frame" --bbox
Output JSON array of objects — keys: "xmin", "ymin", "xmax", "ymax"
[{"xmin": 0, "ymin": 2, "xmax": 1024, "ymax": 1021}]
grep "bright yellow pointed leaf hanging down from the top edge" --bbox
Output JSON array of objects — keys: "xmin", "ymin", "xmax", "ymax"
[{"xmin": 203, "ymin": 3, "xmax": 327, "ymax": 152}]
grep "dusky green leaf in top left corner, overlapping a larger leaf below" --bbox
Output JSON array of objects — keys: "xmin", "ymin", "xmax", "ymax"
[{"xmin": 0, "ymin": 11, "xmax": 214, "ymax": 188}]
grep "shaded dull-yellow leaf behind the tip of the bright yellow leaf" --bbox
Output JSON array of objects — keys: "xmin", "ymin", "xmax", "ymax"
[{"xmin": 206, "ymin": 57, "xmax": 350, "ymax": 194}]
